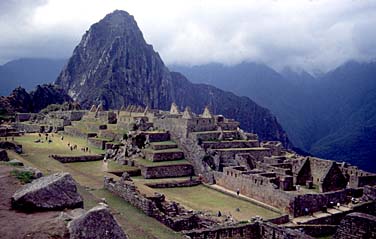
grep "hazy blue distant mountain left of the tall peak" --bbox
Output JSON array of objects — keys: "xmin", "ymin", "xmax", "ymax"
[{"xmin": 0, "ymin": 58, "xmax": 67, "ymax": 96}]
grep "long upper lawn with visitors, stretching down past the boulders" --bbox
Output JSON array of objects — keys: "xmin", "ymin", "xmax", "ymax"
[{"xmin": 1, "ymin": 134, "xmax": 183, "ymax": 239}]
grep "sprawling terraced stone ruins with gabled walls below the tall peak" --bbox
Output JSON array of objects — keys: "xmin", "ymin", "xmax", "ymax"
[{"xmin": 10, "ymin": 104, "xmax": 376, "ymax": 238}]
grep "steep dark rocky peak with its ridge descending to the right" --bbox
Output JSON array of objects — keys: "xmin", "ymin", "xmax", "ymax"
[{"xmin": 56, "ymin": 11, "xmax": 289, "ymax": 146}]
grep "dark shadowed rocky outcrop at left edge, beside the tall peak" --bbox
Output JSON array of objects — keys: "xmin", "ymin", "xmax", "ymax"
[{"xmin": 0, "ymin": 84, "xmax": 72, "ymax": 114}]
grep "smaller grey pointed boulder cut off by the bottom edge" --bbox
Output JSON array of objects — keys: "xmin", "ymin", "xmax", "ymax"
[{"xmin": 68, "ymin": 206, "xmax": 128, "ymax": 239}]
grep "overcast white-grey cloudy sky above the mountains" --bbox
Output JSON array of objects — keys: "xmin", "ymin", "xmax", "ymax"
[{"xmin": 0, "ymin": 0, "xmax": 376, "ymax": 71}]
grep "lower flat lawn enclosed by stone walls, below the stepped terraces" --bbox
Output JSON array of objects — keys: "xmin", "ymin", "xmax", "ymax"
[{"xmin": 155, "ymin": 185, "xmax": 280, "ymax": 220}]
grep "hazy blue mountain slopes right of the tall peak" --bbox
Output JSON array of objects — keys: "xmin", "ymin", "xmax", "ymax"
[{"xmin": 171, "ymin": 61, "xmax": 376, "ymax": 171}]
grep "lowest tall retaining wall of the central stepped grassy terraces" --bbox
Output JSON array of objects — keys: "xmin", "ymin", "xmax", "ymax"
[{"xmin": 140, "ymin": 163, "xmax": 194, "ymax": 179}]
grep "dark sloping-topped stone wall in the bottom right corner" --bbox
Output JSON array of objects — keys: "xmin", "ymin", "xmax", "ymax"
[{"xmin": 333, "ymin": 213, "xmax": 376, "ymax": 239}]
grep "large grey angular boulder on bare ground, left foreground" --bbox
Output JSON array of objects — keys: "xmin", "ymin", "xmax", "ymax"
[{"xmin": 12, "ymin": 173, "xmax": 83, "ymax": 211}]
